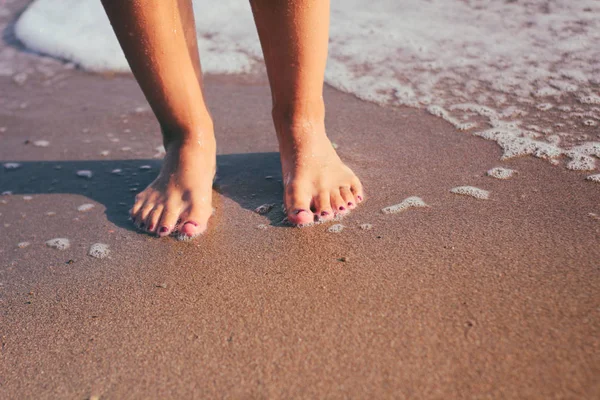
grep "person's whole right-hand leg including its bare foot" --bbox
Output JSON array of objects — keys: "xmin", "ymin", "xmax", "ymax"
[{"xmin": 250, "ymin": 0, "xmax": 364, "ymax": 225}]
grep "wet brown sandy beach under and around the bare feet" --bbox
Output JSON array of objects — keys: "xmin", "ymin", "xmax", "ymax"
[{"xmin": 0, "ymin": 2, "xmax": 600, "ymax": 399}]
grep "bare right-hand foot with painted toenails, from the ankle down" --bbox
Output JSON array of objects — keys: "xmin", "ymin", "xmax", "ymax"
[{"xmin": 275, "ymin": 117, "xmax": 364, "ymax": 226}]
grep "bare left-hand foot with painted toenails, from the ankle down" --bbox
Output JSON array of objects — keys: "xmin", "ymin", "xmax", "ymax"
[{"xmin": 130, "ymin": 130, "xmax": 216, "ymax": 239}]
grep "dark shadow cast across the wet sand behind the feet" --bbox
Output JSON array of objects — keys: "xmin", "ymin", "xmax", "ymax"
[{"xmin": 0, "ymin": 153, "xmax": 284, "ymax": 230}]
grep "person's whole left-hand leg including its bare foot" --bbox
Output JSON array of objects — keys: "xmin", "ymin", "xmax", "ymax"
[{"xmin": 102, "ymin": 0, "xmax": 216, "ymax": 237}]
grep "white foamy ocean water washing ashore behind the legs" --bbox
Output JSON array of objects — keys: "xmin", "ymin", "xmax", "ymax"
[{"xmin": 15, "ymin": 0, "xmax": 600, "ymax": 171}]
